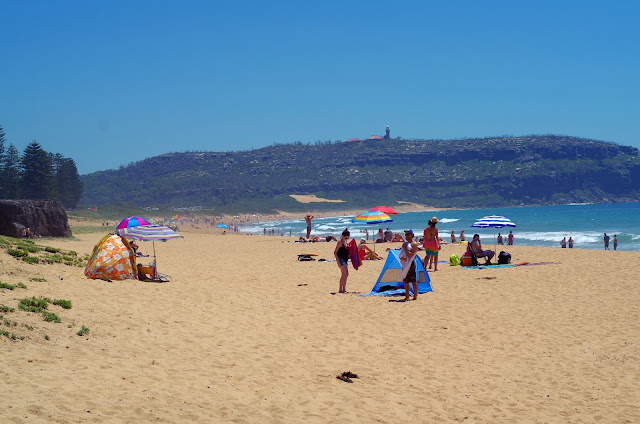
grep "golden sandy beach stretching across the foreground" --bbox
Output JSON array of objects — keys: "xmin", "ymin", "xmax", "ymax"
[{"xmin": 0, "ymin": 224, "xmax": 640, "ymax": 423}]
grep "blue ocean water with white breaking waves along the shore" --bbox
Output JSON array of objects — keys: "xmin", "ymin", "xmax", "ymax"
[{"xmin": 241, "ymin": 202, "xmax": 640, "ymax": 251}]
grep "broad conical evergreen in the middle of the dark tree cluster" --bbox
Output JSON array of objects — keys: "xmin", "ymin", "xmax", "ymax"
[{"xmin": 20, "ymin": 140, "xmax": 54, "ymax": 200}]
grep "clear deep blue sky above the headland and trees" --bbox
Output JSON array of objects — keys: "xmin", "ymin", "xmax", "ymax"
[{"xmin": 0, "ymin": 0, "xmax": 640, "ymax": 173}]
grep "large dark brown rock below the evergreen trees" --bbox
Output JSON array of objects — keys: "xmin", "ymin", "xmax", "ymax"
[{"xmin": 0, "ymin": 200, "xmax": 71, "ymax": 238}]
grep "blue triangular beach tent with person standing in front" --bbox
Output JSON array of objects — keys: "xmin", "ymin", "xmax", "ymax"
[{"xmin": 364, "ymin": 250, "xmax": 433, "ymax": 296}]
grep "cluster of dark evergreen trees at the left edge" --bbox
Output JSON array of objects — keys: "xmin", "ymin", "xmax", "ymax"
[{"xmin": 0, "ymin": 126, "xmax": 83, "ymax": 209}]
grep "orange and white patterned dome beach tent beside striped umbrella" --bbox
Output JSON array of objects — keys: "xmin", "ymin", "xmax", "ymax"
[{"xmin": 84, "ymin": 234, "xmax": 138, "ymax": 280}]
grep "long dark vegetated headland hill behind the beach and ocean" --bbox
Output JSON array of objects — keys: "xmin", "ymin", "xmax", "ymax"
[{"xmin": 82, "ymin": 135, "xmax": 640, "ymax": 212}]
